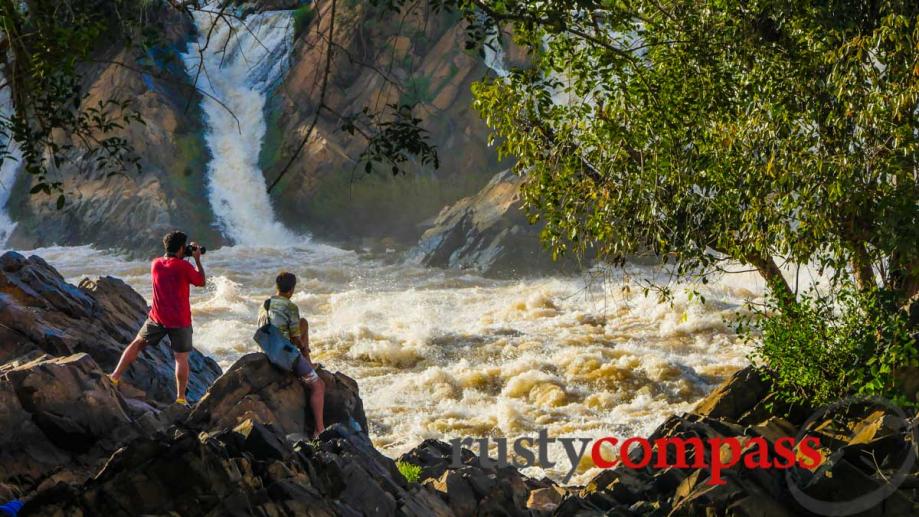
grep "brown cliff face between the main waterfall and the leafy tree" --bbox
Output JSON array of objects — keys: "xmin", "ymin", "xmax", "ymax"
[{"xmin": 261, "ymin": 0, "xmax": 506, "ymax": 243}]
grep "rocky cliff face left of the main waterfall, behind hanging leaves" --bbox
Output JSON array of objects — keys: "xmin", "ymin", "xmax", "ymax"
[{"xmin": 8, "ymin": 2, "xmax": 220, "ymax": 255}]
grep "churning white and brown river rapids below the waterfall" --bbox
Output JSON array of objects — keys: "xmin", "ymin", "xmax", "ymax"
[{"xmin": 18, "ymin": 243, "xmax": 762, "ymax": 483}]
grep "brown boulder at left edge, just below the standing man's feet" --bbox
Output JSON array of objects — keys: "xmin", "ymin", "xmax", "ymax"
[{"xmin": 0, "ymin": 354, "xmax": 156, "ymax": 492}]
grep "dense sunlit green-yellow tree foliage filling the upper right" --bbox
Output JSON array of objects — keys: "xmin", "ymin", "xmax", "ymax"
[{"xmin": 468, "ymin": 0, "xmax": 919, "ymax": 301}]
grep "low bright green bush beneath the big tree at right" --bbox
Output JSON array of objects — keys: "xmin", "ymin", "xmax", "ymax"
[{"xmin": 739, "ymin": 285, "xmax": 919, "ymax": 406}]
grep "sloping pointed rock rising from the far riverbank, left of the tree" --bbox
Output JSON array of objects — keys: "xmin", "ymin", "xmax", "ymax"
[{"xmin": 408, "ymin": 171, "xmax": 561, "ymax": 276}]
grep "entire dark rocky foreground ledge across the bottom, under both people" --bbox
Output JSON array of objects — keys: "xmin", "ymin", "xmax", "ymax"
[{"xmin": 0, "ymin": 253, "xmax": 919, "ymax": 516}]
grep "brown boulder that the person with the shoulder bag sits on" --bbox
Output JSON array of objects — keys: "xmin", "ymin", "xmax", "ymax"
[{"xmin": 189, "ymin": 353, "xmax": 367, "ymax": 436}]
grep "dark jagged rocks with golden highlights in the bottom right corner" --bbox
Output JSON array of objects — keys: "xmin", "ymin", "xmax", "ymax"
[{"xmin": 568, "ymin": 368, "xmax": 919, "ymax": 517}]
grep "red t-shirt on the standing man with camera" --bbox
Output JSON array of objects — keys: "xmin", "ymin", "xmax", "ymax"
[{"xmin": 150, "ymin": 257, "xmax": 204, "ymax": 328}]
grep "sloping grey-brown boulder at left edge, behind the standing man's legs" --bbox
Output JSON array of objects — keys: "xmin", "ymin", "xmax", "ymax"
[{"xmin": 0, "ymin": 251, "xmax": 221, "ymax": 403}]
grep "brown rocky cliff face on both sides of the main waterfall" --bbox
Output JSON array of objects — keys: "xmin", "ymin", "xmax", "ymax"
[{"xmin": 0, "ymin": 0, "xmax": 516, "ymax": 256}]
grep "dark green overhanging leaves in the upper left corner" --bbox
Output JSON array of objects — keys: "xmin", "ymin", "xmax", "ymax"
[{"xmin": 0, "ymin": 0, "xmax": 164, "ymax": 202}]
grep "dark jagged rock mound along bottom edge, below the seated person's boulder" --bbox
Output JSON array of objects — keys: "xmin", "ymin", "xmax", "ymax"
[{"xmin": 22, "ymin": 421, "xmax": 453, "ymax": 516}]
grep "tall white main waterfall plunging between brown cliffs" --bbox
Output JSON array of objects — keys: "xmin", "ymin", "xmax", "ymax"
[{"xmin": 183, "ymin": 4, "xmax": 302, "ymax": 246}]
